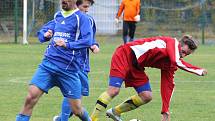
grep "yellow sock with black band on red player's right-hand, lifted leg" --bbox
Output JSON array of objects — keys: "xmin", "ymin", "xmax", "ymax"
[{"xmin": 113, "ymin": 95, "xmax": 145, "ymax": 115}]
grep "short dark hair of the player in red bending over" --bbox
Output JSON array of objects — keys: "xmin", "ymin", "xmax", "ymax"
[{"xmin": 180, "ymin": 35, "xmax": 198, "ymax": 50}]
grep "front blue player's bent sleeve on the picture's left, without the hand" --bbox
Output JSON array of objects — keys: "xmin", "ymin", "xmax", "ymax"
[{"xmin": 37, "ymin": 20, "xmax": 55, "ymax": 43}]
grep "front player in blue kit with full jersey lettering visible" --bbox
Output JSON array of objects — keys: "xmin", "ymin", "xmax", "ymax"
[{"xmin": 16, "ymin": 0, "xmax": 93, "ymax": 121}]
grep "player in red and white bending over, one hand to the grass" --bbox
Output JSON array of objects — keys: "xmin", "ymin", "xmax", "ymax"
[{"xmin": 91, "ymin": 35, "xmax": 207, "ymax": 121}]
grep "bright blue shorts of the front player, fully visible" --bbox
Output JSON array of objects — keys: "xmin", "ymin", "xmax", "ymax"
[{"xmin": 30, "ymin": 59, "xmax": 81, "ymax": 99}]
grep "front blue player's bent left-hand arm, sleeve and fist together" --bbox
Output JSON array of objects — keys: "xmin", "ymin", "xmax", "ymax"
[{"xmin": 37, "ymin": 20, "xmax": 55, "ymax": 43}]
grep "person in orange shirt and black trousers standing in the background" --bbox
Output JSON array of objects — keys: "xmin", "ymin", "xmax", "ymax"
[{"xmin": 115, "ymin": 0, "xmax": 140, "ymax": 44}]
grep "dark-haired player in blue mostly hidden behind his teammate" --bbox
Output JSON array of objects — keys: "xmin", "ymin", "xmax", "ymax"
[{"xmin": 53, "ymin": 0, "xmax": 99, "ymax": 121}]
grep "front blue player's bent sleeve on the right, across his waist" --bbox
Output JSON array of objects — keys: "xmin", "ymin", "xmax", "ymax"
[{"xmin": 66, "ymin": 16, "xmax": 93, "ymax": 49}]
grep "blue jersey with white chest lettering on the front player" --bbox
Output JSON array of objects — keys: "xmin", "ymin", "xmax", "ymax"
[{"xmin": 38, "ymin": 9, "xmax": 93, "ymax": 70}]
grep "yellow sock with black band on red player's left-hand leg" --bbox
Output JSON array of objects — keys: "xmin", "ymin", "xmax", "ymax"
[{"xmin": 91, "ymin": 92, "xmax": 112, "ymax": 121}]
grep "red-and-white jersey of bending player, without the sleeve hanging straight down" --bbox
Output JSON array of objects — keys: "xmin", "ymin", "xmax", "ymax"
[{"xmin": 124, "ymin": 36, "xmax": 203, "ymax": 75}]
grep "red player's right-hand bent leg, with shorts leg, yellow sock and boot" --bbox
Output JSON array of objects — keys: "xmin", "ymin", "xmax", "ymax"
[{"xmin": 107, "ymin": 60, "xmax": 152, "ymax": 121}]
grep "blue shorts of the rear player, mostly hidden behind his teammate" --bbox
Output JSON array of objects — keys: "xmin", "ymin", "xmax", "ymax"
[{"xmin": 78, "ymin": 71, "xmax": 89, "ymax": 96}]
